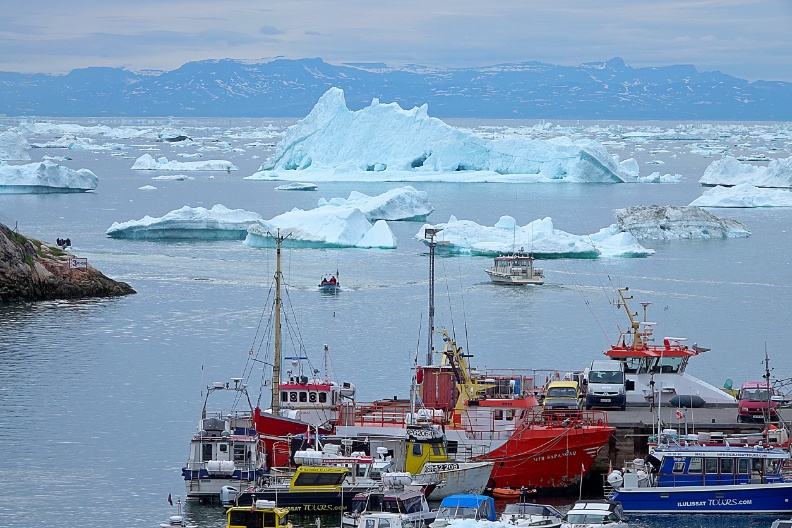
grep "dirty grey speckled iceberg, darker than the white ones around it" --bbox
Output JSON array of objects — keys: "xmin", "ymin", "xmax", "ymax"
[{"xmin": 613, "ymin": 205, "xmax": 751, "ymax": 240}]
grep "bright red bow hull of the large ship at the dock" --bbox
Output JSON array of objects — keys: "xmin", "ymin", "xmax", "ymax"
[{"xmin": 479, "ymin": 425, "xmax": 616, "ymax": 489}]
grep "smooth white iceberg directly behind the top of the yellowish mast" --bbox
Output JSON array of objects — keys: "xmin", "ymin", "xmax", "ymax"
[{"xmin": 244, "ymin": 207, "xmax": 396, "ymax": 249}]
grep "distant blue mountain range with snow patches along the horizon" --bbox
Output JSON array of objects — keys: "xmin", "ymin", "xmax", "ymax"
[{"xmin": 0, "ymin": 58, "xmax": 792, "ymax": 121}]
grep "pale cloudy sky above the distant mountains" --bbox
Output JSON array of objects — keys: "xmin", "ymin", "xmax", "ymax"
[{"xmin": 0, "ymin": 0, "xmax": 792, "ymax": 82}]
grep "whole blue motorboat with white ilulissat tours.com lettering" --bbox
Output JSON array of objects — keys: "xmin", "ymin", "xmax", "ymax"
[{"xmin": 608, "ymin": 443, "xmax": 792, "ymax": 514}]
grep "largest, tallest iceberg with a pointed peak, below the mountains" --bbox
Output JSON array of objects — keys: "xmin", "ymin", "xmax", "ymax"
[{"xmin": 254, "ymin": 88, "xmax": 636, "ymax": 183}]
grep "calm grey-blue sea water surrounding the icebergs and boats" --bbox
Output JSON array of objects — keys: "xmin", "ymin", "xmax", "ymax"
[{"xmin": 0, "ymin": 119, "xmax": 792, "ymax": 527}]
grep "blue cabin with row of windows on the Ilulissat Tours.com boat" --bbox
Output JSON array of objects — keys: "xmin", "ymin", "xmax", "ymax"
[{"xmin": 647, "ymin": 446, "xmax": 789, "ymax": 486}]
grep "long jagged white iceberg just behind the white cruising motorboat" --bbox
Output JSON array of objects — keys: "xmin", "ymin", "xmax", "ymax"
[{"xmin": 415, "ymin": 216, "xmax": 654, "ymax": 259}]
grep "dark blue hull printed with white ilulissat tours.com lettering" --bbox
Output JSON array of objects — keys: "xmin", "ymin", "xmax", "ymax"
[{"xmin": 612, "ymin": 482, "xmax": 792, "ymax": 514}]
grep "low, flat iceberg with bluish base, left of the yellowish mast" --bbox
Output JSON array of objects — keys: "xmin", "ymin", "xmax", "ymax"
[{"xmin": 107, "ymin": 204, "xmax": 261, "ymax": 240}]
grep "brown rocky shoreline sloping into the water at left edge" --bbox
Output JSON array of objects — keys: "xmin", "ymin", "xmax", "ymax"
[{"xmin": 0, "ymin": 224, "xmax": 135, "ymax": 303}]
